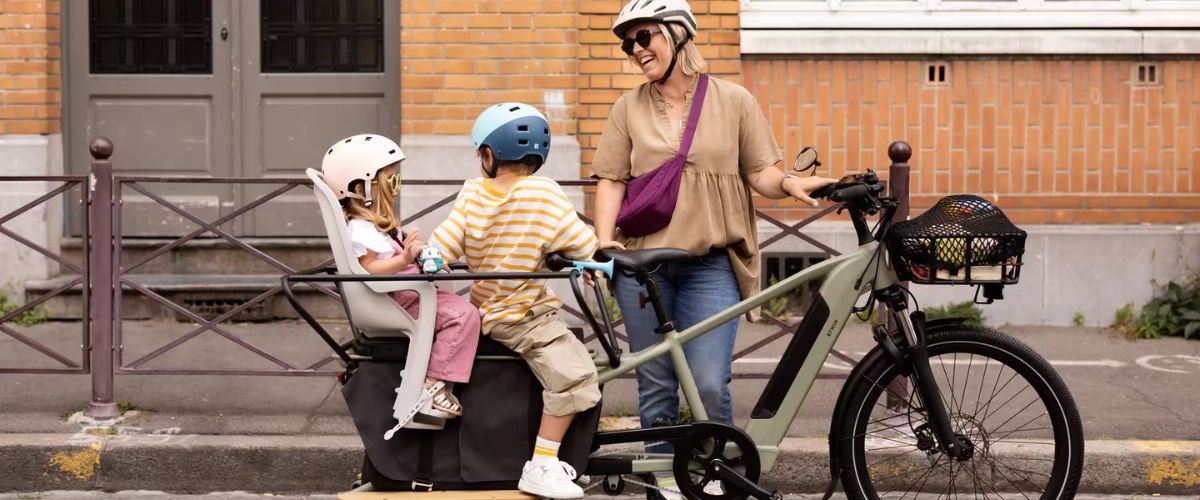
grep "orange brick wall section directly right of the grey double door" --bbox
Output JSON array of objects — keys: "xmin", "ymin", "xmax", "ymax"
[{"xmin": 401, "ymin": 0, "xmax": 580, "ymax": 134}]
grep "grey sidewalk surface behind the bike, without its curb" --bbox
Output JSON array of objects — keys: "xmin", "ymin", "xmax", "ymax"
[{"xmin": 0, "ymin": 321, "xmax": 1200, "ymax": 440}]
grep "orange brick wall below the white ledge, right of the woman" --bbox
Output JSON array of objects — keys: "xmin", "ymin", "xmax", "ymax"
[{"xmin": 743, "ymin": 59, "xmax": 1200, "ymax": 223}]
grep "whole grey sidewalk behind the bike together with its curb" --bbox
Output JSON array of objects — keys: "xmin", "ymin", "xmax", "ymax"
[{"xmin": 0, "ymin": 321, "xmax": 1200, "ymax": 494}]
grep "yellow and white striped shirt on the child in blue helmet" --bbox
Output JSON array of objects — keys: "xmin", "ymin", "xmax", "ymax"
[{"xmin": 430, "ymin": 176, "xmax": 596, "ymax": 332}]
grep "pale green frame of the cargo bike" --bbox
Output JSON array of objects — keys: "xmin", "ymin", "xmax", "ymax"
[{"xmin": 599, "ymin": 241, "xmax": 898, "ymax": 474}]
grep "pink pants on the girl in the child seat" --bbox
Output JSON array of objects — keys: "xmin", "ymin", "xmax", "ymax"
[{"xmin": 392, "ymin": 266, "xmax": 480, "ymax": 382}]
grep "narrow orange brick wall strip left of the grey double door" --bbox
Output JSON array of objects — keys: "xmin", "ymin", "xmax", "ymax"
[{"xmin": 0, "ymin": 0, "xmax": 62, "ymax": 134}]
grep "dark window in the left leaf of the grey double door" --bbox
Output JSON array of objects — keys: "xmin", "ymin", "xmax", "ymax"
[{"xmin": 88, "ymin": 0, "xmax": 212, "ymax": 74}]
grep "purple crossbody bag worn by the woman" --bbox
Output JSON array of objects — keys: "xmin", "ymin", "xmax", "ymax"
[{"xmin": 617, "ymin": 74, "xmax": 708, "ymax": 237}]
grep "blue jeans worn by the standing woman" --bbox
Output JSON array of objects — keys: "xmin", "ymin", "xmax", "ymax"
[{"xmin": 613, "ymin": 249, "xmax": 742, "ymax": 443}]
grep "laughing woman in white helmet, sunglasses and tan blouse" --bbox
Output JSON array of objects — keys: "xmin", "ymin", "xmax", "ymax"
[{"xmin": 592, "ymin": 0, "xmax": 835, "ymax": 494}]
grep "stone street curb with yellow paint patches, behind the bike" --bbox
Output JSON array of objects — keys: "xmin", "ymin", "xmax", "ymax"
[{"xmin": 0, "ymin": 434, "xmax": 1200, "ymax": 494}]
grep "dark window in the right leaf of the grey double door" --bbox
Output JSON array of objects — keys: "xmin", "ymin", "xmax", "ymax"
[{"xmin": 260, "ymin": 0, "xmax": 384, "ymax": 73}]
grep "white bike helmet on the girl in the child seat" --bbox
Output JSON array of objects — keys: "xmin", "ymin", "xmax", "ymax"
[{"xmin": 320, "ymin": 134, "xmax": 404, "ymax": 206}]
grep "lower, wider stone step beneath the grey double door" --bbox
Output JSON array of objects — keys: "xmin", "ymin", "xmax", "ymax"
[{"xmin": 25, "ymin": 275, "xmax": 346, "ymax": 321}]
